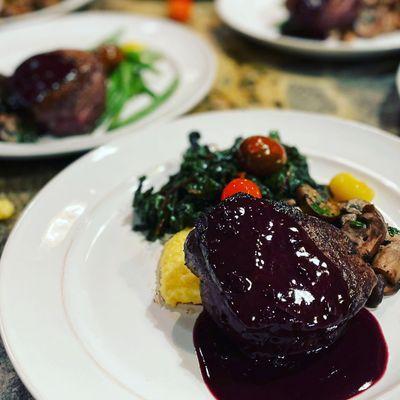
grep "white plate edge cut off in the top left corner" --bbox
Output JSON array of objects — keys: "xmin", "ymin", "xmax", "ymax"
[{"xmin": 0, "ymin": 0, "xmax": 93, "ymax": 30}]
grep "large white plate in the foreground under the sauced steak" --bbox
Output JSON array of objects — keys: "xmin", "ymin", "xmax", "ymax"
[{"xmin": 0, "ymin": 111, "xmax": 400, "ymax": 400}]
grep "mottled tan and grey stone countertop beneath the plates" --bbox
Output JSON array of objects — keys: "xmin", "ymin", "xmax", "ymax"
[{"xmin": 0, "ymin": 0, "xmax": 400, "ymax": 400}]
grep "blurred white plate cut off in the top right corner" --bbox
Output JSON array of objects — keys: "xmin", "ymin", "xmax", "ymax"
[{"xmin": 216, "ymin": 0, "xmax": 400, "ymax": 57}]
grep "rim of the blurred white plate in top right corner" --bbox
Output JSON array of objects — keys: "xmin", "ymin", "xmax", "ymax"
[{"xmin": 215, "ymin": 0, "xmax": 400, "ymax": 59}]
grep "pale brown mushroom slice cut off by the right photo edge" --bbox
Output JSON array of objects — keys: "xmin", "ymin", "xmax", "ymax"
[{"xmin": 372, "ymin": 235, "xmax": 400, "ymax": 291}]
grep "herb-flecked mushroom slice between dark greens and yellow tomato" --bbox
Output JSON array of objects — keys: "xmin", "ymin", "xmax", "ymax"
[{"xmin": 296, "ymin": 185, "xmax": 340, "ymax": 222}]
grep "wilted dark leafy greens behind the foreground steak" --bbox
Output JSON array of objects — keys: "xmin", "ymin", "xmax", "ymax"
[{"xmin": 133, "ymin": 132, "xmax": 317, "ymax": 240}]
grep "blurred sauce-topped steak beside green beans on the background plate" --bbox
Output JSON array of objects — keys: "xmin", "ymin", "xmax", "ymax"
[{"xmin": 9, "ymin": 50, "xmax": 106, "ymax": 136}]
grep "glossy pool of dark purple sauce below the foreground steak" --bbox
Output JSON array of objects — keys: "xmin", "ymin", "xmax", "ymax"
[{"xmin": 193, "ymin": 309, "xmax": 388, "ymax": 400}]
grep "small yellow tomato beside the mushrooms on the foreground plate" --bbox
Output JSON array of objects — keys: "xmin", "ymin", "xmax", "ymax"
[{"xmin": 329, "ymin": 172, "xmax": 375, "ymax": 202}]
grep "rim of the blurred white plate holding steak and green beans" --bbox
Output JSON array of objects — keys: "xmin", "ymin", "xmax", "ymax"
[{"xmin": 0, "ymin": 10, "xmax": 218, "ymax": 159}]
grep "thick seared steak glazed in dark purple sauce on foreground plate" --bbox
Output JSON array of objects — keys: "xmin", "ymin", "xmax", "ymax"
[{"xmin": 185, "ymin": 194, "xmax": 376, "ymax": 358}]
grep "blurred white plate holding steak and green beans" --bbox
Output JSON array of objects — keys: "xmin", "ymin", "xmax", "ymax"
[{"xmin": 0, "ymin": 12, "xmax": 216, "ymax": 157}]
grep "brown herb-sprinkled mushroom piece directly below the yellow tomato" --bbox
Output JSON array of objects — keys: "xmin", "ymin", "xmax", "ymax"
[{"xmin": 342, "ymin": 204, "xmax": 387, "ymax": 260}]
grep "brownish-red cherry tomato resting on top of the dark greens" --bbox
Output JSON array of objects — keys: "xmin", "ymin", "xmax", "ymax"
[{"xmin": 238, "ymin": 136, "xmax": 287, "ymax": 176}]
